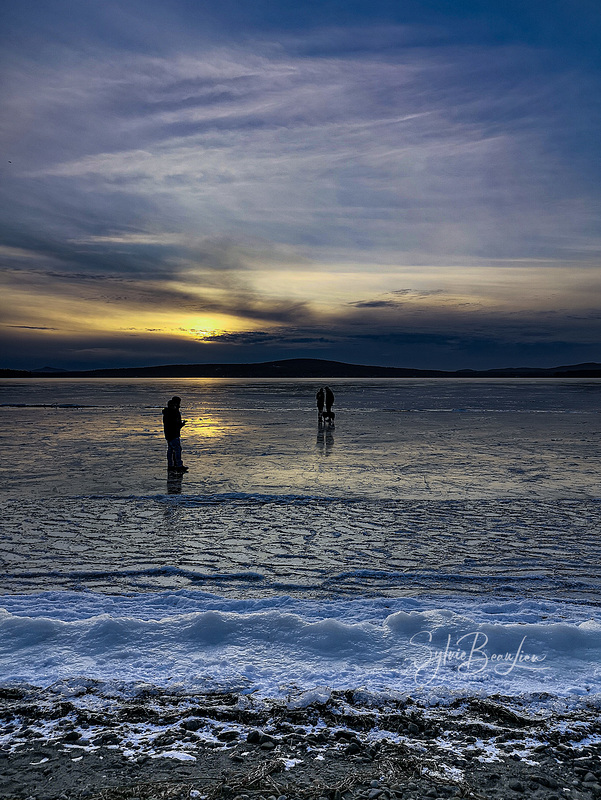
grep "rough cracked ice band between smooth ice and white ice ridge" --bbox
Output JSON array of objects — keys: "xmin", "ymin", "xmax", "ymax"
[{"xmin": 0, "ymin": 495, "xmax": 601, "ymax": 602}]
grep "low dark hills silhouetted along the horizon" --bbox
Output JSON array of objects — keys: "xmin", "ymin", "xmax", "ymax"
[{"xmin": 0, "ymin": 358, "xmax": 601, "ymax": 379}]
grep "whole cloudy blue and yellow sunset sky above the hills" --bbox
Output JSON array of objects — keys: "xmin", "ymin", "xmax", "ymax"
[{"xmin": 0, "ymin": 0, "xmax": 601, "ymax": 369}]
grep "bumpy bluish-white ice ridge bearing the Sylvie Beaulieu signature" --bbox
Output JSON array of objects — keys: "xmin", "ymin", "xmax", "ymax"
[{"xmin": 0, "ymin": 591, "xmax": 601, "ymax": 708}]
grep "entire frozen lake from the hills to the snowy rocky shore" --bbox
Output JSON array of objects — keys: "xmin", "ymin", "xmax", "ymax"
[{"xmin": 0, "ymin": 379, "xmax": 601, "ymax": 702}]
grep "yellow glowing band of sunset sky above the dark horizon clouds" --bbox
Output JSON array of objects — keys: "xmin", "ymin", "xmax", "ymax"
[{"xmin": 0, "ymin": 261, "xmax": 601, "ymax": 350}]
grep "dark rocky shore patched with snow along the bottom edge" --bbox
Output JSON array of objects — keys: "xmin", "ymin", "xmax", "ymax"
[{"xmin": 0, "ymin": 682, "xmax": 601, "ymax": 800}]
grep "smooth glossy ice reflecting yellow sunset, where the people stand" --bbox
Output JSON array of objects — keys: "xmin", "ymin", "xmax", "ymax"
[{"xmin": 0, "ymin": 379, "xmax": 601, "ymax": 500}]
